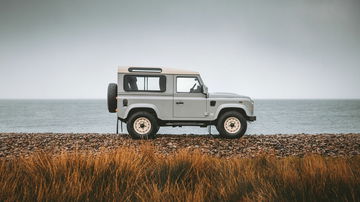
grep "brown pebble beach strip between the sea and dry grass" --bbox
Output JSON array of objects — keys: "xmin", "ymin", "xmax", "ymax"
[{"xmin": 0, "ymin": 133, "xmax": 360, "ymax": 158}]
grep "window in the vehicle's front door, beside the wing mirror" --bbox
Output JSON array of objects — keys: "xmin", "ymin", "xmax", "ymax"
[{"xmin": 176, "ymin": 77, "xmax": 201, "ymax": 93}]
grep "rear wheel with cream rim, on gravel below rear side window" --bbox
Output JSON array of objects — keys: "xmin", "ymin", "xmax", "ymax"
[{"xmin": 126, "ymin": 111, "xmax": 159, "ymax": 139}]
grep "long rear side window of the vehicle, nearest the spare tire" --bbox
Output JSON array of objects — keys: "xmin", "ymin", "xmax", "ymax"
[{"xmin": 124, "ymin": 75, "xmax": 166, "ymax": 92}]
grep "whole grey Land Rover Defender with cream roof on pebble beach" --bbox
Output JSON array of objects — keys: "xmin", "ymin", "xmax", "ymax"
[{"xmin": 107, "ymin": 67, "xmax": 256, "ymax": 139}]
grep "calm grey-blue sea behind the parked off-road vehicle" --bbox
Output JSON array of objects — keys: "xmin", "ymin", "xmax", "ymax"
[{"xmin": 0, "ymin": 100, "xmax": 360, "ymax": 135}]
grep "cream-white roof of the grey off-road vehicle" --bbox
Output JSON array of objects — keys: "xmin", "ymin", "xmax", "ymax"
[{"xmin": 118, "ymin": 66, "xmax": 199, "ymax": 74}]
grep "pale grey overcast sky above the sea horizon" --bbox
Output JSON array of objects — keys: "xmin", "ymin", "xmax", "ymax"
[{"xmin": 0, "ymin": 0, "xmax": 360, "ymax": 99}]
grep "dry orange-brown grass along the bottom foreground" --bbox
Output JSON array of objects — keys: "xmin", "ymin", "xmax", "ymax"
[{"xmin": 0, "ymin": 147, "xmax": 360, "ymax": 201}]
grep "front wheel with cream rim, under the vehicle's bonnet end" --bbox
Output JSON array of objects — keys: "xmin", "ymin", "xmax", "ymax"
[{"xmin": 216, "ymin": 111, "xmax": 247, "ymax": 139}]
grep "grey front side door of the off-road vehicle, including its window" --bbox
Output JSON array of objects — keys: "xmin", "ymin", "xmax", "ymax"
[{"xmin": 173, "ymin": 76, "xmax": 206, "ymax": 120}]
